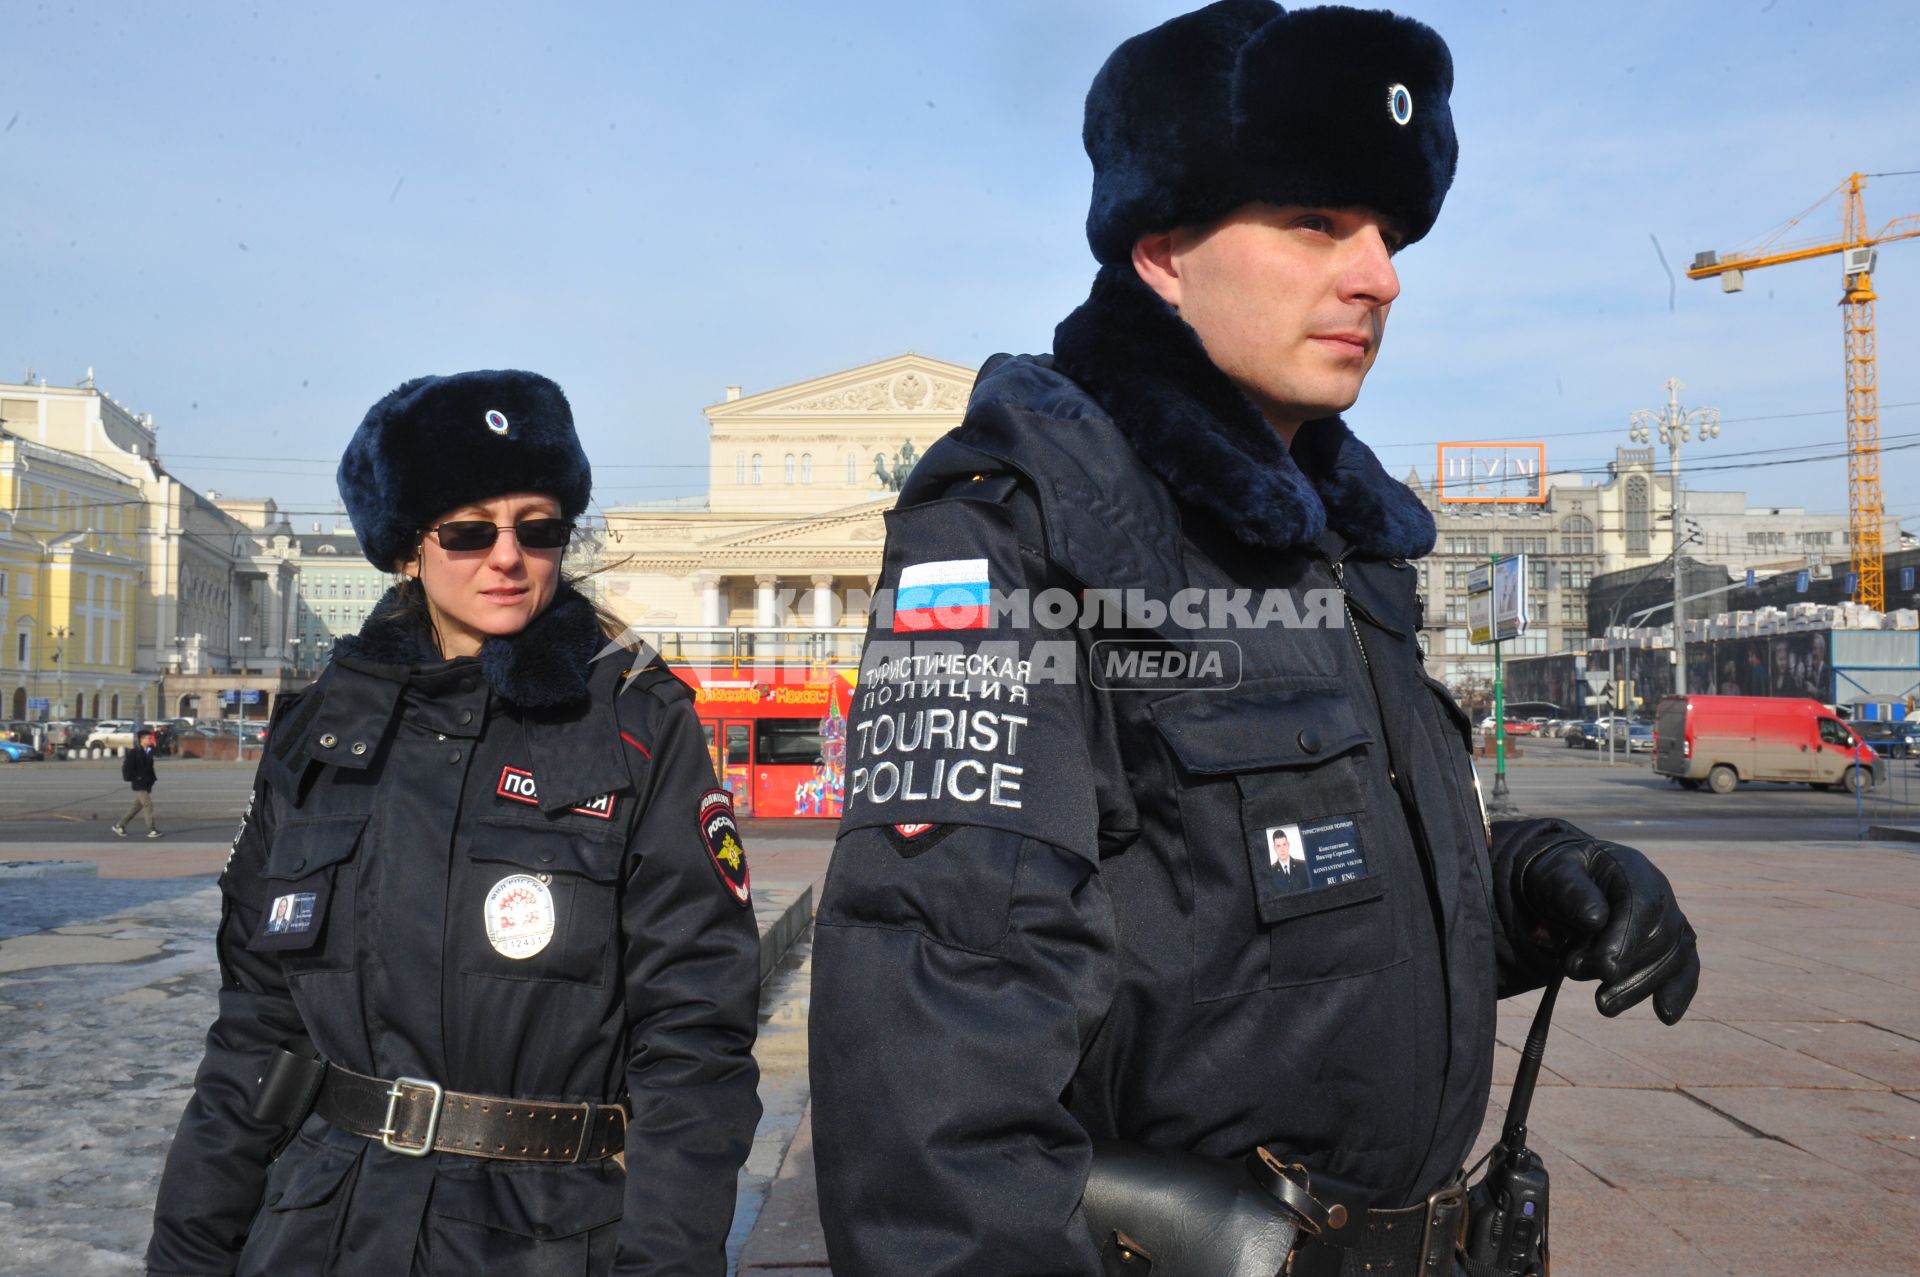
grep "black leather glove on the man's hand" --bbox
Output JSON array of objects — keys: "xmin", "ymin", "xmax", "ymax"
[{"xmin": 1519, "ymin": 839, "xmax": 1699, "ymax": 1024}]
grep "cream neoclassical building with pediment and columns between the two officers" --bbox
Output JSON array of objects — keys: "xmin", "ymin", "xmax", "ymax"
[{"xmin": 595, "ymin": 353, "xmax": 973, "ymax": 630}]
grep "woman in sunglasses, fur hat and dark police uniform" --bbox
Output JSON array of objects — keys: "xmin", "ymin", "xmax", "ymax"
[{"xmin": 146, "ymin": 373, "xmax": 760, "ymax": 1277}]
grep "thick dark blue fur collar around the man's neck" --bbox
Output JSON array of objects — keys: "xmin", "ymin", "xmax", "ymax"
[{"xmin": 1054, "ymin": 263, "xmax": 1434, "ymax": 559}]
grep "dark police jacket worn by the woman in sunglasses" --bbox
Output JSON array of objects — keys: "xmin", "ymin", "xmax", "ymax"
[{"xmin": 146, "ymin": 591, "xmax": 760, "ymax": 1277}]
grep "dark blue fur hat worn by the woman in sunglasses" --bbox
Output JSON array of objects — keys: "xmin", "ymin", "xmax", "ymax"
[{"xmin": 338, "ymin": 369, "xmax": 593, "ymax": 570}]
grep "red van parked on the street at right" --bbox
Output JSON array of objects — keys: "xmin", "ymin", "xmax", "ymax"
[{"xmin": 1653, "ymin": 695, "xmax": 1887, "ymax": 793}]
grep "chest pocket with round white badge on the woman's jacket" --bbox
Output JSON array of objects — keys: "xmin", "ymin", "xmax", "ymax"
[{"xmin": 449, "ymin": 816, "xmax": 624, "ymax": 989}]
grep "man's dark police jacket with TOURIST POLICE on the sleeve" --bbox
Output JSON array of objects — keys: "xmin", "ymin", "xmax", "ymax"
[{"xmin": 810, "ymin": 267, "xmax": 1563, "ymax": 1277}]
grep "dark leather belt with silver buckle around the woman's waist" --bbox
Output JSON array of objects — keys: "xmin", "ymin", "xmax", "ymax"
[{"xmin": 313, "ymin": 1064, "xmax": 626, "ymax": 1162}]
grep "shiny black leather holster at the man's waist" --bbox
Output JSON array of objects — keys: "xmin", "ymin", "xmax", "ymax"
[{"xmin": 1081, "ymin": 1141, "xmax": 1313, "ymax": 1277}]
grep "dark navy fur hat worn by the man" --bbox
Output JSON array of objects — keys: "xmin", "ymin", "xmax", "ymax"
[{"xmin": 1081, "ymin": 0, "xmax": 1459, "ymax": 263}]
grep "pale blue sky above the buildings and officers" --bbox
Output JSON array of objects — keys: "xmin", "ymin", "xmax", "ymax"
[{"xmin": 0, "ymin": 0, "xmax": 1920, "ymax": 526}]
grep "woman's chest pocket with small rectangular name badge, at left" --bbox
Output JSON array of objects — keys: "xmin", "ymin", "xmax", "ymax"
[{"xmin": 248, "ymin": 812, "xmax": 367, "ymax": 976}]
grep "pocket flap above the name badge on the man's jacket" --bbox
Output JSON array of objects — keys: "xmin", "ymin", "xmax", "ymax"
[{"xmin": 1146, "ymin": 686, "xmax": 1373, "ymax": 772}]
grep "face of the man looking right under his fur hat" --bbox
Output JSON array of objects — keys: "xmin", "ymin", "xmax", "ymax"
[{"xmin": 1135, "ymin": 204, "xmax": 1400, "ymax": 436}]
